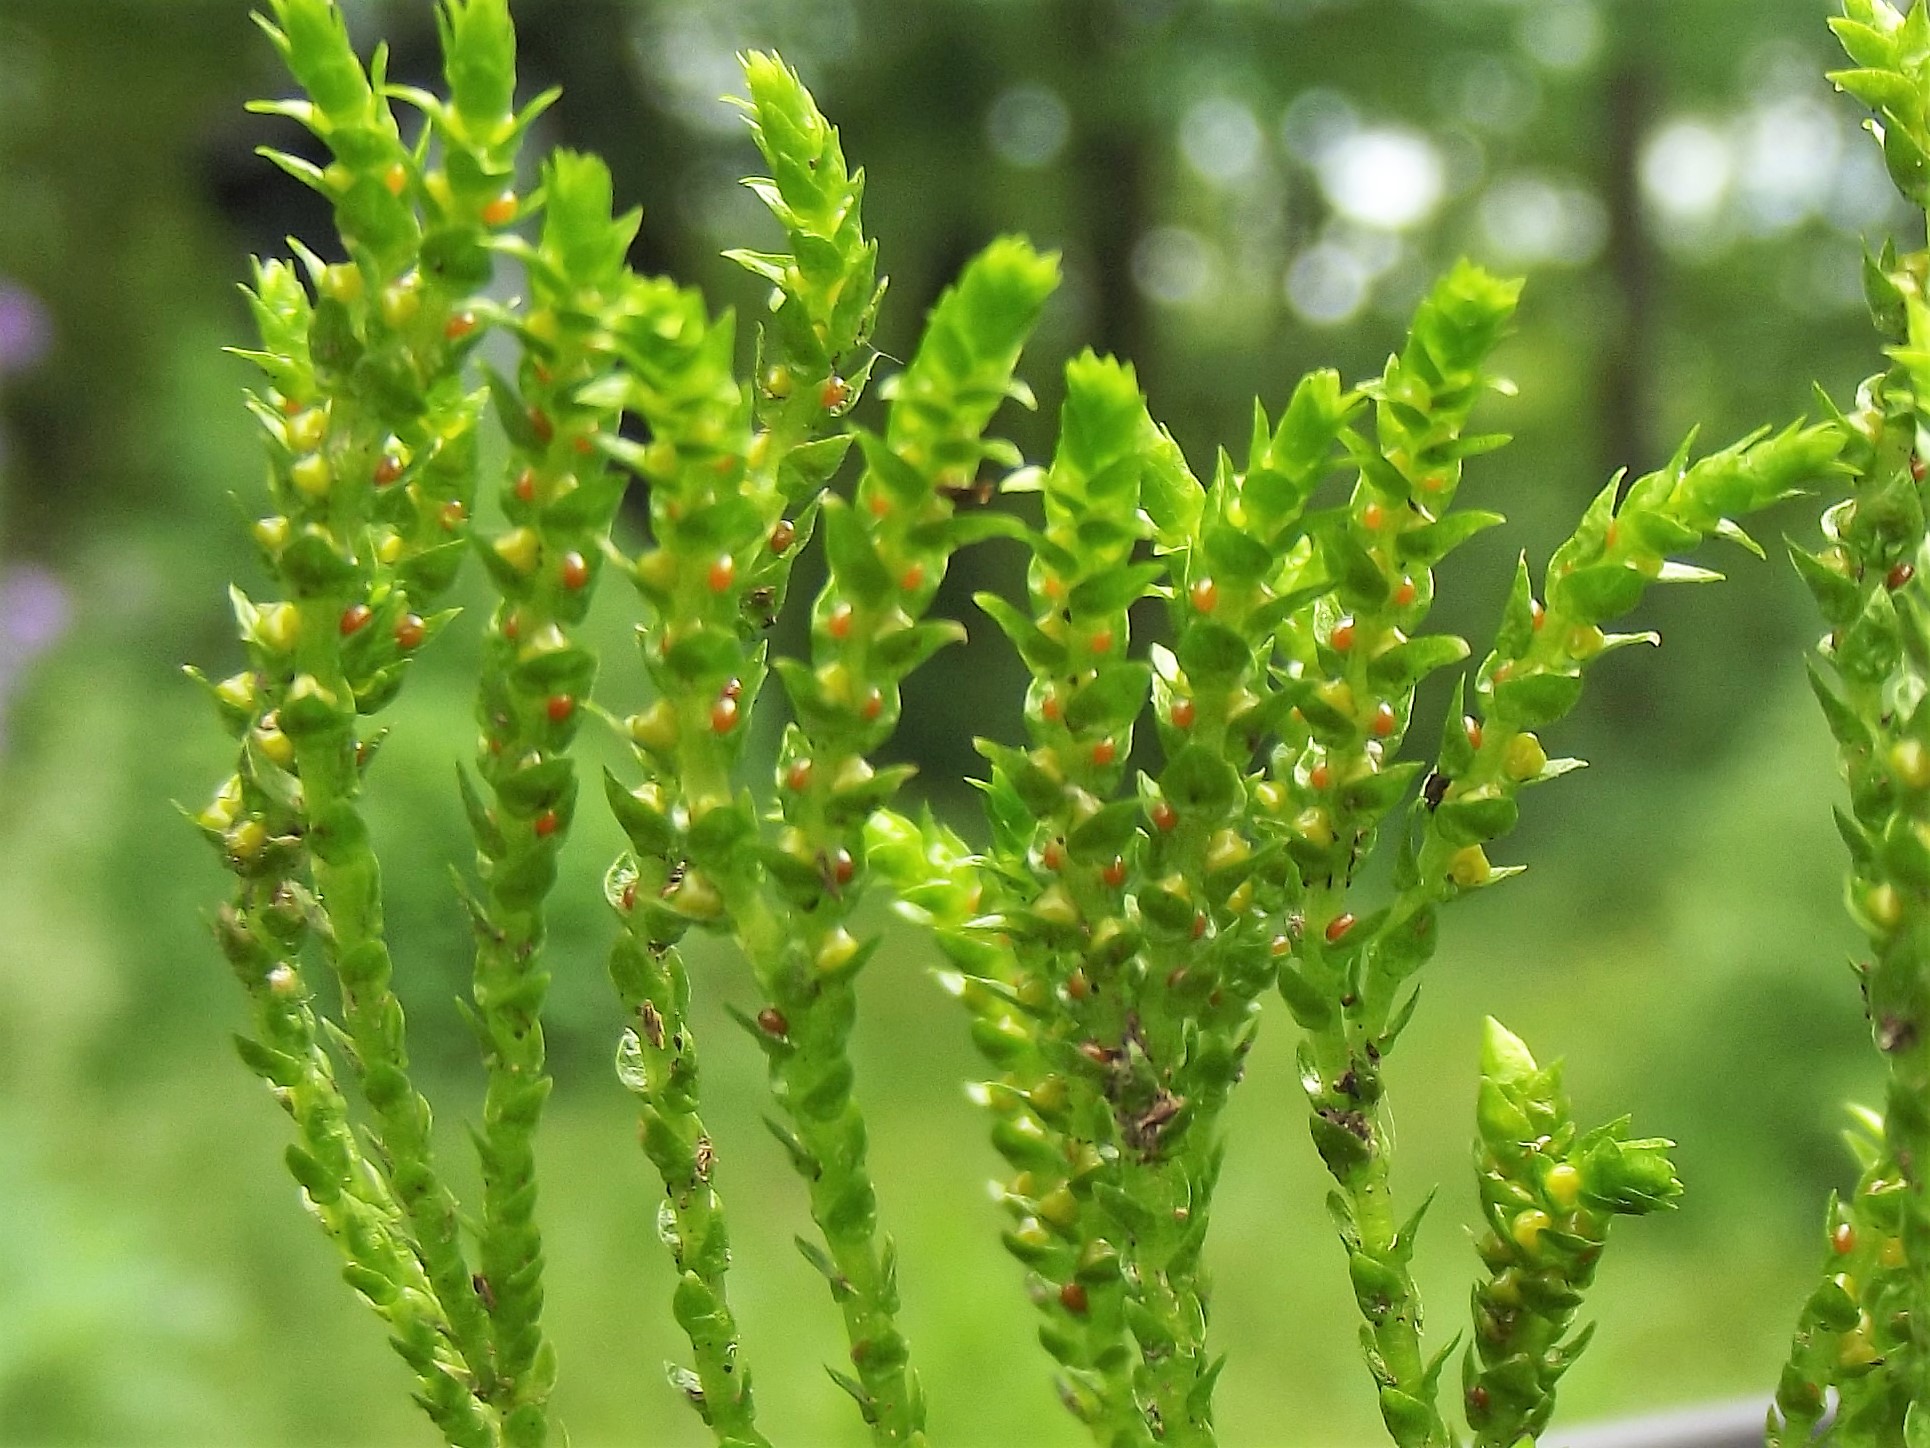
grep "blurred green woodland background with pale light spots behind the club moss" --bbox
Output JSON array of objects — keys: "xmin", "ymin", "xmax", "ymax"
[{"xmin": 0, "ymin": 0, "xmax": 1920, "ymax": 1448}]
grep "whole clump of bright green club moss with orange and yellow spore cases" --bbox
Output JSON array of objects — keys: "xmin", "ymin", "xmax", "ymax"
[{"xmin": 184, "ymin": 0, "xmax": 1930, "ymax": 1448}]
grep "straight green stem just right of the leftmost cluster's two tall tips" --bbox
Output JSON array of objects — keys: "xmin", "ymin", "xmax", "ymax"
[{"xmin": 463, "ymin": 153, "xmax": 635, "ymax": 1448}]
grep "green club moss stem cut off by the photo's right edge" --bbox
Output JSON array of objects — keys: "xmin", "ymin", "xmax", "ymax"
[{"xmin": 1768, "ymin": 0, "xmax": 1930, "ymax": 1448}]
